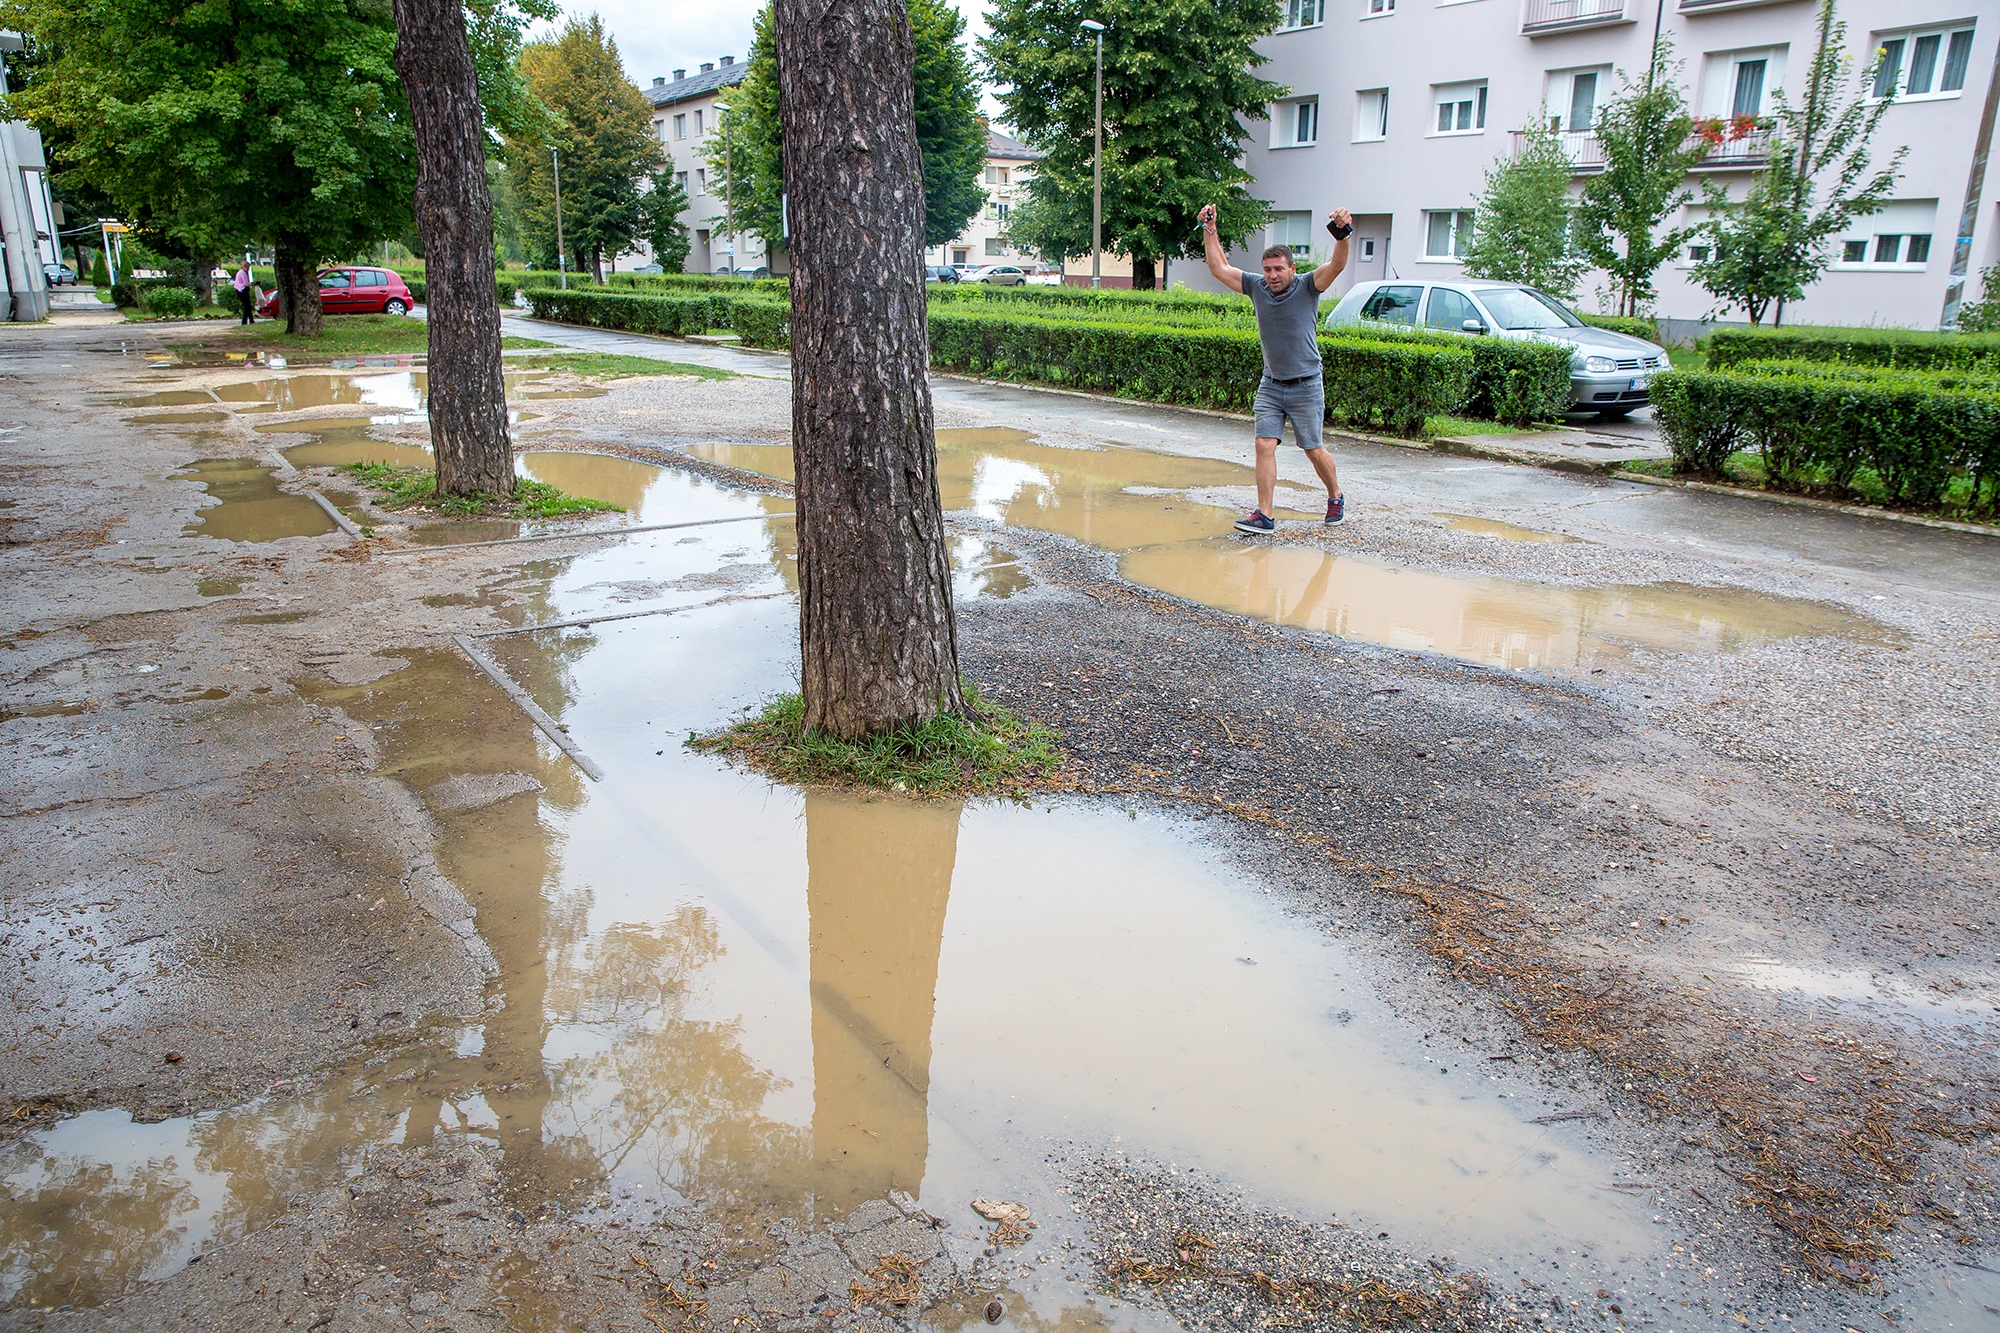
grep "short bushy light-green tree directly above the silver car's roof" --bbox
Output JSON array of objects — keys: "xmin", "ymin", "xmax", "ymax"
[{"xmin": 1464, "ymin": 120, "xmax": 1590, "ymax": 300}]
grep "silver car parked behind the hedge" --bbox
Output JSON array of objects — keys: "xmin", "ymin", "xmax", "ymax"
[{"xmin": 1326, "ymin": 278, "xmax": 1668, "ymax": 420}]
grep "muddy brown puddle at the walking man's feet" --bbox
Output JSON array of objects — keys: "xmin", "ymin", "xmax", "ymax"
[{"xmin": 688, "ymin": 428, "xmax": 1892, "ymax": 671}]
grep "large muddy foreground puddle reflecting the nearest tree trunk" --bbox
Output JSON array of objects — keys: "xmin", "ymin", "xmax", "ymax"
[{"xmin": 0, "ymin": 472, "xmax": 1660, "ymax": 1323}]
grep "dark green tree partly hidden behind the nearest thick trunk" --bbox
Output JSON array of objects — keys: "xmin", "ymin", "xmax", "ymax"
[{"xmin": 706, "ymin": 0, "xmax": 986, "ymax": 248}]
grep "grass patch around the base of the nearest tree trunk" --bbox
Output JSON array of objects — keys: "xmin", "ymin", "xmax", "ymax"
[{"xmin": 688, "ymin": 687, "xmax": 1062, "ymax": 799}]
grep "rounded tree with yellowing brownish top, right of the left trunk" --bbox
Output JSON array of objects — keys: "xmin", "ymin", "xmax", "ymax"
[{"xmin": 506, "ymin": 14, "xmax": 666, "ymax": 282}]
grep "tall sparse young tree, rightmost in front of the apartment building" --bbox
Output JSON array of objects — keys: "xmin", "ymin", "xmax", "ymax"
[{"xmin": 1694, "ymin": 0, "xmax": 1908, "ymax": 324}]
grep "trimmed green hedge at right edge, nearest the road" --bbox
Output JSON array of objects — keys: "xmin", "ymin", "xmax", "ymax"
[{"xmin": 1652, "ymin": 366, "xmax": 2000, "ymax": 512}]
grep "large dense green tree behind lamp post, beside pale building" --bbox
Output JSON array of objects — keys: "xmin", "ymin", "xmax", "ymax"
[{"xmin": 980, "ymin": 0, "xmax": 1286, "ymax": 286}]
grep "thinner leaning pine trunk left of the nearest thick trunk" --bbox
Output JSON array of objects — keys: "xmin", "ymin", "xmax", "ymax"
[{"xmin": 396, "ymin": 0, "xmax": 514, "ymax": 494}]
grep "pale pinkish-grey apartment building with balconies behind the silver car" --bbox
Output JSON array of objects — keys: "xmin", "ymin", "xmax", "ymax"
[{"xmin": 1176, "ymin": 0, "xmax": 2000, "ymax": 328}]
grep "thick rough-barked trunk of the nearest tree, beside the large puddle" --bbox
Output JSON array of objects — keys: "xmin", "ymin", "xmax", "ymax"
[{"xmin": 776, "ymin": 0, "xmax": 964, "ymax": 739}]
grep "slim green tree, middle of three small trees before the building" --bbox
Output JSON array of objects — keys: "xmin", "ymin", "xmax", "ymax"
[{"xmin": 1576, "ymin": 38, "xmax": 1710, "ymax": 314}]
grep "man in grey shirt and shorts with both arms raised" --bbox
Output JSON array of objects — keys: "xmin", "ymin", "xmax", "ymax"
[{"xmin": 1200, "ymin": 204, "xmax": 1354, "ymax": 534}]
